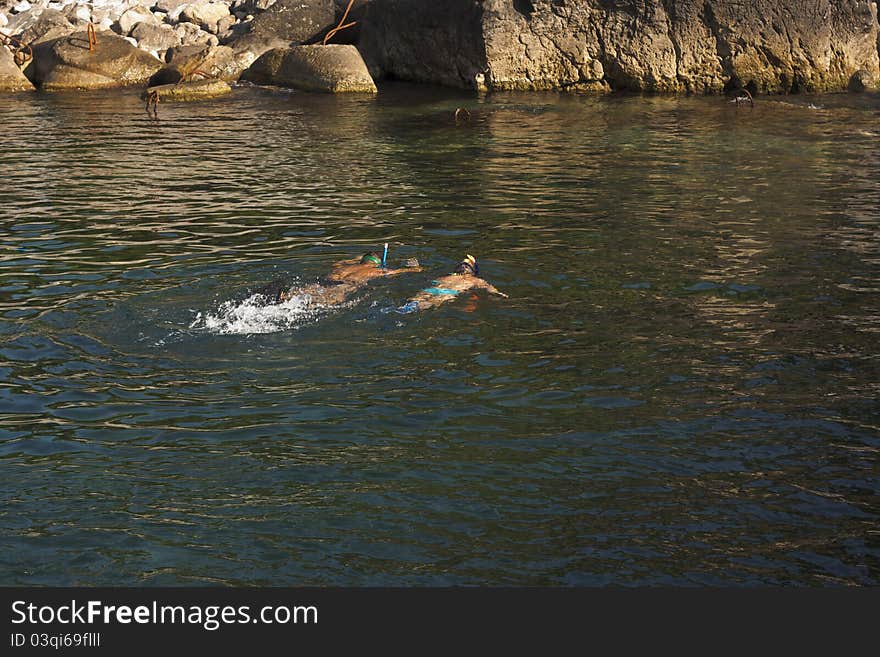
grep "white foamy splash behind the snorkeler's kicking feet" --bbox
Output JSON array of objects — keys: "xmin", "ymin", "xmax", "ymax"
[{"xmin": 189, "ymin": 294, "xmax": 329, "ymax": 335}]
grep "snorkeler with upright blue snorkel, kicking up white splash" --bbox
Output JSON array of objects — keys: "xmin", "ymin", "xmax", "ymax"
[{"xmin": 257, "ymin": 248, "xmax": 422, "ymax": 306}]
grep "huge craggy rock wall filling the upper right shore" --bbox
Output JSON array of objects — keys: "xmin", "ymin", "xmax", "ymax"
[{"xmin": 360, "ymin": 0, "xmax": 880, "ymax": 93}]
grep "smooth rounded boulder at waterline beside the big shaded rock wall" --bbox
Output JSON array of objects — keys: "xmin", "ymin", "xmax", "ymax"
[{"xmin": 242, "ymin": 44, "xmax": 376, "ymax": 93}]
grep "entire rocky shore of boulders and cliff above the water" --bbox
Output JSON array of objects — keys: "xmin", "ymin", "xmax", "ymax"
[{"xmin": 0, "ymin": 0, "xmax": 880, "ymax": 93}]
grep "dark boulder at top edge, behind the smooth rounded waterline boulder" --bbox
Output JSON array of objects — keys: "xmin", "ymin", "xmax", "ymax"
[{"xmin": 227, "ymin": 0, "xmax": 336, "ymax": 66}]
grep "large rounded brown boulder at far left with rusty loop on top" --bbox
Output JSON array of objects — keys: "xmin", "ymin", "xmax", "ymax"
[{"xmin": 28, "ymin": 31, "xmax": 162, "ymax": 91}]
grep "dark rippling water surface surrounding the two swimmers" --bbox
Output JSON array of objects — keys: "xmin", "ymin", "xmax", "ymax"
[{"xmin": 0, "ymin": 86, "xmax": 880, "ymax": 585}]
